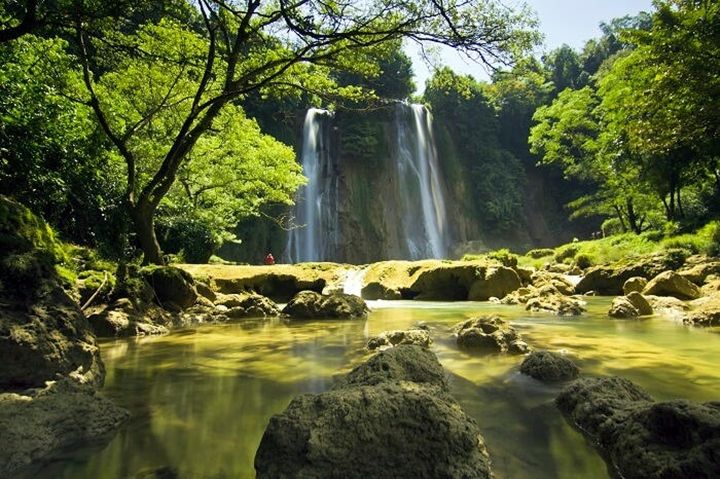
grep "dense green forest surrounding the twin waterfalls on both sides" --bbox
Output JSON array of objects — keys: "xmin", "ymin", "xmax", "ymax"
[{"xmin": 0, "ymin": 1, "xmax": 720, "ymax": 263}]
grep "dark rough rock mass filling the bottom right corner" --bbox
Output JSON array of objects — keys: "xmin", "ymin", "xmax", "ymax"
[{"xmin": 555, "ymin": 377, "xmax": 720, "ymax": 479}]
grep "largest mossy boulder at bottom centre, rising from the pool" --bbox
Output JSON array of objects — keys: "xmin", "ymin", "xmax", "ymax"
[{"xmin": 255, "ymin": 345, "xmax": 492, "ymax": 479}]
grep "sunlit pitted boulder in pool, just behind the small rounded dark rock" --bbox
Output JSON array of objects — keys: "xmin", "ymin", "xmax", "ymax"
[{"xmin": 453, "ymin": 316, "xmax": 530, "ymax": 354}]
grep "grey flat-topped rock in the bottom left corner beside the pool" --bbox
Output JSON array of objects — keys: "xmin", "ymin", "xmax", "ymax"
[{"xmin": 0, "ymin": 379, "xmax": 129, "ymax": 477}]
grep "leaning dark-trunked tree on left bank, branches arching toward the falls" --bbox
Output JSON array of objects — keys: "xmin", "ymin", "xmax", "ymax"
[{"xmin": 64, "ymin": 0, "xmax": 537, "ymax": 263}]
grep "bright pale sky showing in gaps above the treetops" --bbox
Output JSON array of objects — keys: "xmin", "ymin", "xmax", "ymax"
[{"xmin": 408, "ymin": 0, "xmax": 652, "ymax": 93}]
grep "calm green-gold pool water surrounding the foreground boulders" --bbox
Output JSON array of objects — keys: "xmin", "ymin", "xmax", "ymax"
[{"xmin": 22, "ymin": 298, "xmax": 720, "ymax": 479}]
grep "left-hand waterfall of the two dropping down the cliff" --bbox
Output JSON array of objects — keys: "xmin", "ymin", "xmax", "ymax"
[{"xmin": 286, "ymin": 108, "xmax": 338, "ymax": 263}]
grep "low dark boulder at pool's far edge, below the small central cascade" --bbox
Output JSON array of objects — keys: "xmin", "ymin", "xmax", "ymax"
[{"xmin": 282, "ymin": 291, "xmax": 369, "ymax": 319}]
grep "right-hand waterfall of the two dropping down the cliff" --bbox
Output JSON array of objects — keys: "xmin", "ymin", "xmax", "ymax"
[{"xmin": 395, "ymin": 103, "xmax": 448, "ymax": 259}]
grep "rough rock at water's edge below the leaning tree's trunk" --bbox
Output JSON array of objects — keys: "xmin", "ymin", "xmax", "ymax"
[{"xmin": 88, "ymin": 298, "xmax": 171, "ymax": 338}]
